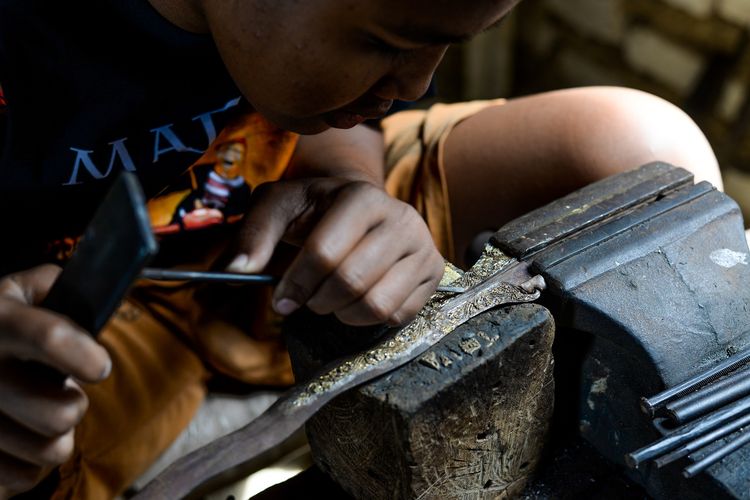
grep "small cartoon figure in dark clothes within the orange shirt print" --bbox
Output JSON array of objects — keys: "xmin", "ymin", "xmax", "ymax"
[{"xmin": 174, "ymin": 138, "xmax": 250, "ymax": 230}]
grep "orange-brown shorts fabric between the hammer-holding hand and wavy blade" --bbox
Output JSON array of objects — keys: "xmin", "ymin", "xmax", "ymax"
[{"xmin": 53, "ymin": 300, "xmax": 208, "ymax": 499}]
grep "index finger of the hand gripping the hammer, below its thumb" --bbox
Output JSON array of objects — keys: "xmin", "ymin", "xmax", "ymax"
[{"xmin": 0, "ymin": 298, "xmax": 112, "ymax": 382}]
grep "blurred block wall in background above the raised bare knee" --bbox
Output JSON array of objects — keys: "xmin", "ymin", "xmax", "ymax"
[{"xmin": 437, "ymin": 0, "xmax": 750, "ymax": 226}]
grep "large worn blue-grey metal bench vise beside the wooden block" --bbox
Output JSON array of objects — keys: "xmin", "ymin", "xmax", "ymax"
[{"xmin": 493, "ymin": 163, "xmax": 750, "ymax": 498}]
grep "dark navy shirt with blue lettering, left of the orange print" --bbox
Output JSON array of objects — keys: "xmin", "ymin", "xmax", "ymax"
[{"xmin": 0, "ymin": 0, "xmax": 246, "ymax": 269}]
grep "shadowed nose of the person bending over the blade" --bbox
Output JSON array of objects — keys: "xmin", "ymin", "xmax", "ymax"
[{"xmin": 373, "ymin": 46, "xmax": 447, "ymax": 101}]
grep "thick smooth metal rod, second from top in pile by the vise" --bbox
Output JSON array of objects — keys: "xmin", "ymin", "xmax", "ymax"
[{"xmin": 665, "ymin": 368, "xmax": 750, "ymax": 425}]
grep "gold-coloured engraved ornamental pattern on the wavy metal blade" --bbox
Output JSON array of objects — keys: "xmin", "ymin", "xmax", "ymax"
[{"xmin": 287, "ymin": 245, "xmax": 539, "ymax": 411}]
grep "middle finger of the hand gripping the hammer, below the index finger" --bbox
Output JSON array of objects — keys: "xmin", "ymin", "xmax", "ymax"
[{"xmin": 0, "ymin": 360, "xmax": 88, "ymax": 437}]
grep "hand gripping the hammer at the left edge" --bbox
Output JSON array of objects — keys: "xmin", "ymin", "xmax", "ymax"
[{"xmin": 0, "ymin": 265, "xmax": 111, "ymax": 493}]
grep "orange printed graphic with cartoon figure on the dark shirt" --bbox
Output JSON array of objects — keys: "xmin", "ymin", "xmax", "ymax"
[{"xmin": 148, "ymin": 113, "xmax": 297, "ymax": 235}]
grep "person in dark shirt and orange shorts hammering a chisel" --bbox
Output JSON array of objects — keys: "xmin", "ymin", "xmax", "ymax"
[{"xmin": 0, "ymin": 0, "xmax": 720, "ymax": 498}]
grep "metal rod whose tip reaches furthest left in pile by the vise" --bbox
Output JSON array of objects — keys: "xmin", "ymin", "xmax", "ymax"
[{"xmin": 625, "ymin": 396, "xmax": 750, "ymax": 469}]
